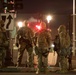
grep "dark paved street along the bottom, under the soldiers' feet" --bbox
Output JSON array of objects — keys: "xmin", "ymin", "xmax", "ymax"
[{"xmin": 0, "ymin": 66, "xmax": 76, "ymax": 75}]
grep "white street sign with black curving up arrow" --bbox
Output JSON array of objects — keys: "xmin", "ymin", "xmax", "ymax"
[{"xmin": 1, "ymin": 13, "xmax": 14, "ymax": 30}]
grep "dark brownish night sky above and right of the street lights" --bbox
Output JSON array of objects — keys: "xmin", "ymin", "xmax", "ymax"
[{"xmin": 18, "ymin": 0, "xmax": 73, "ymax": 37}]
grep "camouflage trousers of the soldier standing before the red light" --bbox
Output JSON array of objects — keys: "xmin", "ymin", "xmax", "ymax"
[{"xmin": 36, "ymin": 48, "xmax": 48, "ymax": 73}]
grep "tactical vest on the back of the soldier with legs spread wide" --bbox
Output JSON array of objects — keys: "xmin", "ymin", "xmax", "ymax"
[{"xmin": 18, "ymin": 27, "xmax": 32, "ymax": 44}]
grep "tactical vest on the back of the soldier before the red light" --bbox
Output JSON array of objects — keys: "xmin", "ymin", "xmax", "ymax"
[{"xmin": 38, "ymin": 30, "xmax": 51, "ymax": 48}]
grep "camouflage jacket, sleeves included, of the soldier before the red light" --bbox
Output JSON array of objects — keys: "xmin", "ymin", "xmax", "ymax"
[{"xmin": 35, "ymin": 30, "xmax": 51, "ymax": 49}]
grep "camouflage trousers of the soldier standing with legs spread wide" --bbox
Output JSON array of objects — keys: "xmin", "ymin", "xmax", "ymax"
[{"xmin": 17, "ymin": 45, "xmax": 33, "ymax": 67}]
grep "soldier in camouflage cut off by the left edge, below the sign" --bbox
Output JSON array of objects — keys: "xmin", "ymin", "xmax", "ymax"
[{"xmin": 0, "ymin": 20, "xmax": 8, "ymax": 67}]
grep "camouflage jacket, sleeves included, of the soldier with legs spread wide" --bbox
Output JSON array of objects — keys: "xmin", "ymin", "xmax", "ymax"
[{"xmin": 16, "ymin": 27, "xmax": 34, "ymax": 43}]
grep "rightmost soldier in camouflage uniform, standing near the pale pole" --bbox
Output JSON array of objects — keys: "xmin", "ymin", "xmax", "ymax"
[{"xmin": 58, "ymin": 25, "xmax": 70, "ymax": 73}]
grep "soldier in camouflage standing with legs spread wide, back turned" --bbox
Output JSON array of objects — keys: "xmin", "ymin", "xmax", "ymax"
[{"xmin": 16, "ymin": 21, "xmax": 34, "ymax": 67}]
